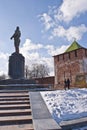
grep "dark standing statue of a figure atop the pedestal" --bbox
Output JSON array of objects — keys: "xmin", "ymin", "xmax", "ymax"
[{"xmin": 10, "ymin": 26, "xmax": 21, "ymax": 53}]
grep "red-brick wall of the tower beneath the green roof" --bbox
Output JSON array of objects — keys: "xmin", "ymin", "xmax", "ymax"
[{"xmin": 54, "ymin": 48, "xmax": 87, "ymax": 87}]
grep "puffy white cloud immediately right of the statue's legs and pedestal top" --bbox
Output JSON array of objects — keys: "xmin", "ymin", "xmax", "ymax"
[{"xmin": 20, "ymin": 39, "xmax": 43, "ymax": 66}]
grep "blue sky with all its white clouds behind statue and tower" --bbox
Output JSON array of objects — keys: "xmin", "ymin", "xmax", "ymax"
[{"xmin": 0, "ymin": 0, "xmax": 87, "ymax": 75}]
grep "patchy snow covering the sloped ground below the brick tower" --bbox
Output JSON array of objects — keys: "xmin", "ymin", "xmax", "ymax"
[{"xmin": 40, "ymin": 88, "xmax": 87, "ymax": 123}]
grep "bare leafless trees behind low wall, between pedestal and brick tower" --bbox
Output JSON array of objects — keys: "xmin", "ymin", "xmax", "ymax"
[{"xmin": 25, "ymin": 64, "xmax": 49, "ymax": 78}]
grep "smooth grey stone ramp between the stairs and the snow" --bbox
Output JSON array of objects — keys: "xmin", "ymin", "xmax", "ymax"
[{"xmin": 29, "ymin": 92, "xmax": 61, "ymax": 130}]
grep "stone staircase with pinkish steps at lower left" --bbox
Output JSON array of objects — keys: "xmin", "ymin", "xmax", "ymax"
[{"xmin": 0, "ymin": 90, "xmax": 34, "ymax": 130}]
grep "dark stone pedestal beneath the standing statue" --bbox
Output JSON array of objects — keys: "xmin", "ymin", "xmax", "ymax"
[{"xmin": 8, "ymin": 52, "xmax": 25, "ymax": 79}]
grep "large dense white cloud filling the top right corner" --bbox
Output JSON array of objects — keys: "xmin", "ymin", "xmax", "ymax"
[{"xmin": 55, "ymin": 0, "xmax": 87, "ymax": 22}]
